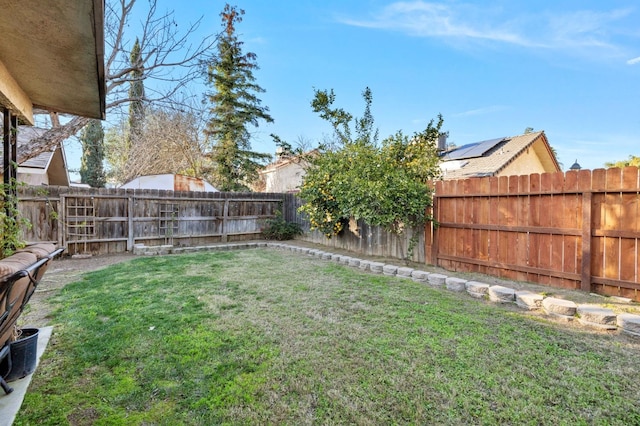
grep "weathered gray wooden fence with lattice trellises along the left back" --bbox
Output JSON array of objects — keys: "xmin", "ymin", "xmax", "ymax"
[{"xmin": 19, "ymin": 187, "xmax": 283, "ymax": 254}]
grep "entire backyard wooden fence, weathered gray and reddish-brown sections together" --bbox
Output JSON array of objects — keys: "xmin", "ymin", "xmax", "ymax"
[{"xmin": 13, "ymin": 167, "xmax": 640, "ymax": 301}]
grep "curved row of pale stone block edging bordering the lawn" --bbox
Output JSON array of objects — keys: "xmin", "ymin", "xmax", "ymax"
[{"xmin": 133, "ymin": 241, "xmax": 640, "ymax": 337}]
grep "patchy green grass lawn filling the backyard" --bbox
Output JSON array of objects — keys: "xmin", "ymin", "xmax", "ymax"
[{"xmin": 15, "ymin": 249, "xmax": 640, "ymax": 425}]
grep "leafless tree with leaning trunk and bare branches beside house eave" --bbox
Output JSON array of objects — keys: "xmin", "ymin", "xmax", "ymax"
[{"xmin": 18, "ymin": 0, "xmax": 218, "ymax": 163}]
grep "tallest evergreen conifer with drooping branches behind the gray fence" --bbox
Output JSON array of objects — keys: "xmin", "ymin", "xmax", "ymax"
[{"xmin": 205, "ymin": 4, "xmax": 273, "ymax": 191}]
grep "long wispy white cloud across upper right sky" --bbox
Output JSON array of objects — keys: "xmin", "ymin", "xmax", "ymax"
[{"xmin": 341, "ymin": 0, "xmax": 637, "ymax": 56}]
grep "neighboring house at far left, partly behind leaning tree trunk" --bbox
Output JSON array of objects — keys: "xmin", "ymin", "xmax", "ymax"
[{"xmin": 0, "ymin": 126, "xmax": 70, "ymax": 186}]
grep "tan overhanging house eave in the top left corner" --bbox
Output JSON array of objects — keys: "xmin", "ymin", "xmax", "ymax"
[{"xmin": 0, "ymin": 0, "xmax": 106, "ymax": 121}]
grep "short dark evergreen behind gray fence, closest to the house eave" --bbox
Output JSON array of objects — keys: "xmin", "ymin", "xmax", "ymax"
[{"xmin": 80, "ymin": 120, "xmax": 106, "ymax": 188}]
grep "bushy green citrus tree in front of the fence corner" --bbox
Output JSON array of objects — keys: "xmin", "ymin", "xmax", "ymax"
[{"xmin": 300, "ymin": 88, "xmax": 443, "ymax": 254}]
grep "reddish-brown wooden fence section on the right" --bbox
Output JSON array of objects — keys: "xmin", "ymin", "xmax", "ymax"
[{"xmin": 425, "ymin": 167, "xmax": 640, "ymax": 301}]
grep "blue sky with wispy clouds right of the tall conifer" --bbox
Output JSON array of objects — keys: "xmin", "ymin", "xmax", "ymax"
[{"xmin": 67, "ymin": 0, "xmax": 640, "ymax": 175}]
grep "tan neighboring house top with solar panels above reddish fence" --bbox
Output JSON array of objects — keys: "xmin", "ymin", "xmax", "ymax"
[{"xmin": 440, "ymin": 131, "xmax": 560, "ymax": 179}]
